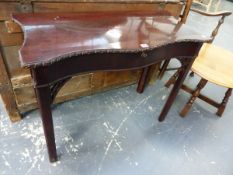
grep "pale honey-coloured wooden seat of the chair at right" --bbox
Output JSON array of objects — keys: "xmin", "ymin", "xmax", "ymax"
[{"xmin": 191, "ymin": 43, "xmax": 233, "ymax": 88}]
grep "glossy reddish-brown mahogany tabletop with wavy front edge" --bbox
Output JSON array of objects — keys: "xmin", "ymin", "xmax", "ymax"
[{"xmin": 13, "ymin": 11, "xmax": 206, "ymax": 66}]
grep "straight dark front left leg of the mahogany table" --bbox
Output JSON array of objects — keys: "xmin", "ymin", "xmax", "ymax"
[{"xmin": 35, "ymin": 87, "xmax": 57, "ymax": 162}]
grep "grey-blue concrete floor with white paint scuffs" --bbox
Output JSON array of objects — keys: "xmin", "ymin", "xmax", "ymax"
[{"xmin": 0, "ymin": 1, "xmax": 233, "ymax": 175}]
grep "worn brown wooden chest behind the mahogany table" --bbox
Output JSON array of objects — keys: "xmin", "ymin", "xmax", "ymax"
[{"xmin": 0, "ymin": 0, "xmax": 191, "ymax": 121}]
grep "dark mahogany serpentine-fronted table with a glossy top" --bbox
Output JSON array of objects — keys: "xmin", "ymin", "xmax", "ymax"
[{"xmin": 13, "ymin": 11, "xmax": 209, "ymax": 162}]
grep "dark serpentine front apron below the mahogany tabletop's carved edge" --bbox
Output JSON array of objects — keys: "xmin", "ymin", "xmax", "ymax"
[{"xmin": 30, "ymin": 41, "xmax": 202, "ymax": 88}]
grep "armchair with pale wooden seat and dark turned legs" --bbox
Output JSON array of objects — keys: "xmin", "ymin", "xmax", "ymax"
[{"xmin": 159, "ymin": 9, "xmax": 233, "ymax": 117}]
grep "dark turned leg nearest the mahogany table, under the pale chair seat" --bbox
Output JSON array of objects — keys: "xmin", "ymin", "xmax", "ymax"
[{"xmin": 180, "ymin": 78, "xmax": 207, "ymax": 117}]
